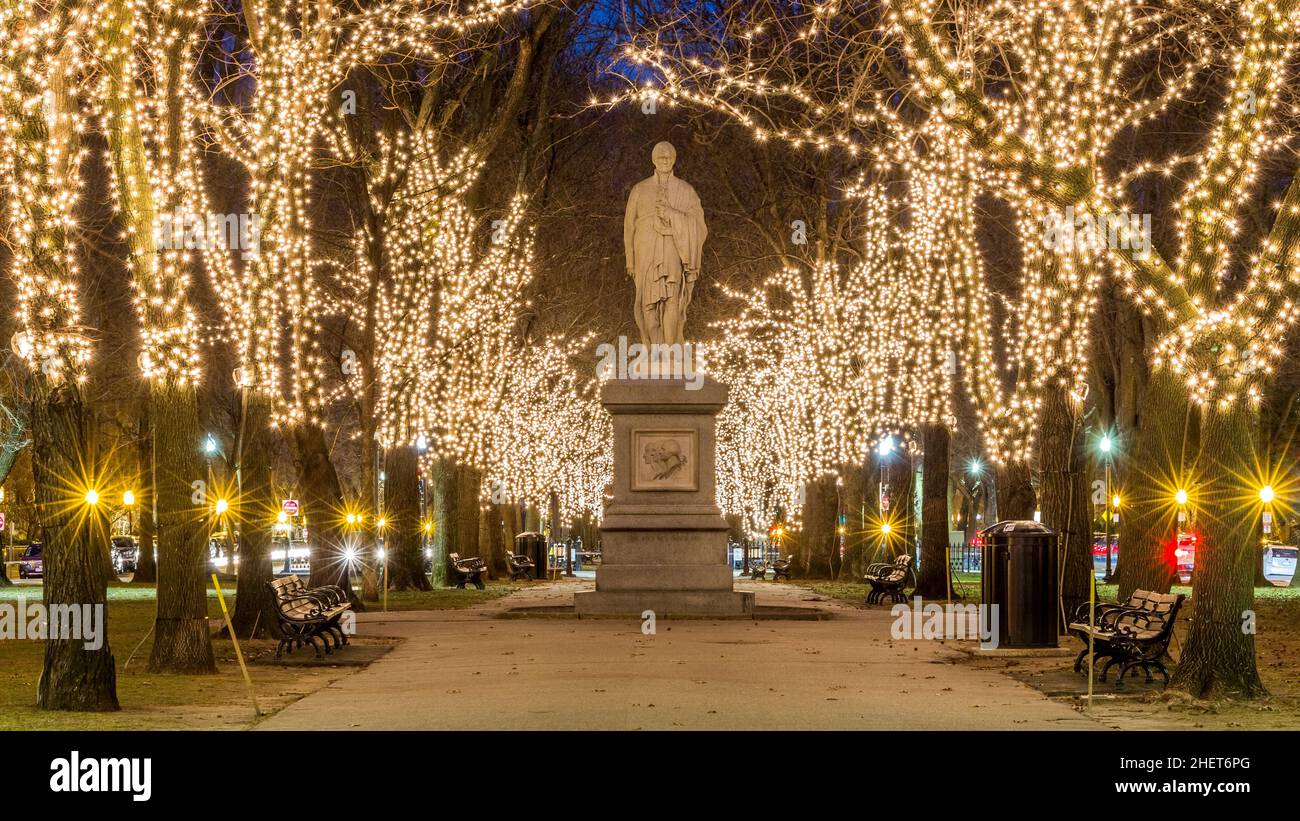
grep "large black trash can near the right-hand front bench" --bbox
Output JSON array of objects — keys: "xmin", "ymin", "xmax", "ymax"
[{"xmin": 980, "ymin": 521, "xmax": 1060, "ymax": 647}]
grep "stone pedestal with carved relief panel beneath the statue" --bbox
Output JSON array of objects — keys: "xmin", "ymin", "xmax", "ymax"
[{"xmin": 573, "ymin": 378, "xmax": 754, "ymax": 618}]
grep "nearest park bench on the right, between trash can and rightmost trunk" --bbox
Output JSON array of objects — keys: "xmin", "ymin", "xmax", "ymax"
[{"xmin": 1070, "ymin": 590, "xmax": 1183, "ymax": 685}]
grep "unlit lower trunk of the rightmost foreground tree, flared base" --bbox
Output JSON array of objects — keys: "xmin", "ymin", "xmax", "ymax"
[{"xmin": 1170, "ymin": 404, "xmax": 1268, "ymax": 699}]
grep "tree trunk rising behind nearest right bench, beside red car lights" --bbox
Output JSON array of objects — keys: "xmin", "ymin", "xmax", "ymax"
[{"xmin": 1115, "ymin": 369, "xmax": 1196, "ymax": 600}]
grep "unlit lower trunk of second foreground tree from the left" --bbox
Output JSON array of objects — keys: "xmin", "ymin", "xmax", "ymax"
[{"xmin": 148, "ymin": 378, "xmax": 217, "ymax": 673}]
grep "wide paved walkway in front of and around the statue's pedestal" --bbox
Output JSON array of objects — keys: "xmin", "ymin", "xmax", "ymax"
[{"xmin": 259, "ymin": 582, "xmax": 1100, "ymax": 730}]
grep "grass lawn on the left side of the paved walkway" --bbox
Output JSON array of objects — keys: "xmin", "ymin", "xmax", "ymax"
[{"xmin": 0, "ymin": 582, "xmax": 519, "ymax": 730}]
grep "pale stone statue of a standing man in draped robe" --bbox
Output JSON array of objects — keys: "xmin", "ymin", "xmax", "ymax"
[{"xmin": 623, "ymin": 143, "xmax": 709, "ymax": 346}]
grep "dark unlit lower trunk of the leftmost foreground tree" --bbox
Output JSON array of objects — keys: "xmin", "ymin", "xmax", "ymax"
[{"xmin": 31, "ymin": 384, "xmax": 118, "ymax": 712}]
